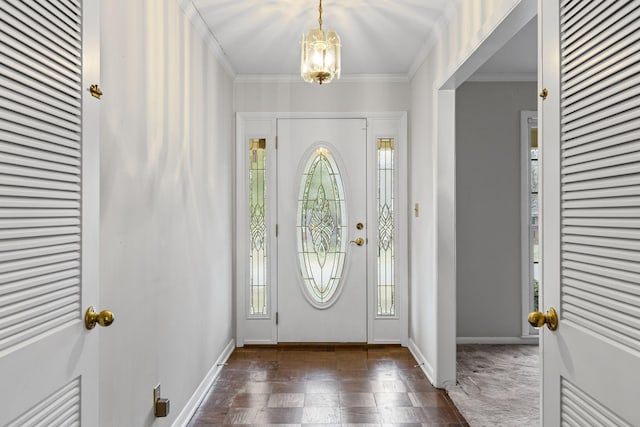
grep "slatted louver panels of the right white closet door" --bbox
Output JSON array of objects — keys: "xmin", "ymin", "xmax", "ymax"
[{"xmin": 560, "ymin": 1, "xmax": 640, "ymax": 354}]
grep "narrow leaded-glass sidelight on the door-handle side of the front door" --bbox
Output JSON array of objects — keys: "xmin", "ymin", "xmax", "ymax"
[{"xmin": 376, "ymin": 138, "xmax": 396, "ymax": 316}]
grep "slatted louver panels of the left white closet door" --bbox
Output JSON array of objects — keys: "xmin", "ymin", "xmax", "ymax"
[{"xmin": 0, "ymin": 0, "xmax": 82, "ymax": 356}]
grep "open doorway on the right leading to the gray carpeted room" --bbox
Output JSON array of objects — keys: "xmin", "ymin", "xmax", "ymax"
[{"xmin": 438, "ymin": 3, "xmax": 539, "ymax": 425}]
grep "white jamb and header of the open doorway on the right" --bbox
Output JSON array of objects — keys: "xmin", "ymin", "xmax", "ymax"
[{"xmin": 429, "ymin": 0, "xmax": 538, "ymax": 387}]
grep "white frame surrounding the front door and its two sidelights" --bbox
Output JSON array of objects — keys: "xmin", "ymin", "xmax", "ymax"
[{"xmin": 235, "ymin": 112, "xmax": 409, "ymax": 347}]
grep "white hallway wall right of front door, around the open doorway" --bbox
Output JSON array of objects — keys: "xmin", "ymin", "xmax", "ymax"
[{"xmin": 409, "ymin": 0, "xmax": 535, "ymax": 387}]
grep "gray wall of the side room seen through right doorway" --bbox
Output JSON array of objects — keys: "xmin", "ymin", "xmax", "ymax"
[{"xmin": 456, "ymin": 82, "xmax": 537, "ymax": 337}]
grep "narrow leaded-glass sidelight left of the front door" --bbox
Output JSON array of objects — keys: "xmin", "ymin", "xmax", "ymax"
[{"xmin": 249, "ymin": 138, "xmax": 269, "ymax": 316}]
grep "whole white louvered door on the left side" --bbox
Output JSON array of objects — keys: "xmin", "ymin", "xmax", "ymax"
[{"xmin": 0, "ymin": 0, "xmax": 99, "ymax": 426}]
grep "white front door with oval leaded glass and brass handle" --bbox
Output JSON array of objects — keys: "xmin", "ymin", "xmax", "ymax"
[{"xmin": 277, "ymin": 119, "xmax": 367, "ymax": 342}]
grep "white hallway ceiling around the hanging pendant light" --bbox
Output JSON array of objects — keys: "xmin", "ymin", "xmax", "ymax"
[{"xmin": 192, "ymin": 0, "xmax": 457, "ymax": 76}]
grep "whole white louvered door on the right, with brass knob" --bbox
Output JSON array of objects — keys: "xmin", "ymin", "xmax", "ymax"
[{"xmin": 540, "ymin": 0, "xmax": 640, "ymax": 427}]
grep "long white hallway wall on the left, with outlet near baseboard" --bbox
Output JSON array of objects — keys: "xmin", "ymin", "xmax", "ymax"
[{"xmin": 99, "ymin": 0, "xmax": 233, "ymax": 426}]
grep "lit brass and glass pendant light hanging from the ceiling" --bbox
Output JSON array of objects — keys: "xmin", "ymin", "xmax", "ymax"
[{"xmin": 300, "ymin": 0, "xmax": 341, "ymax": 84}]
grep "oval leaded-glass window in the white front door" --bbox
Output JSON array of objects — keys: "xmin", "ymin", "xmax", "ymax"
[{"xmin": 296, "ymin": 147, "xmax": 347, "ymax": 308}]
